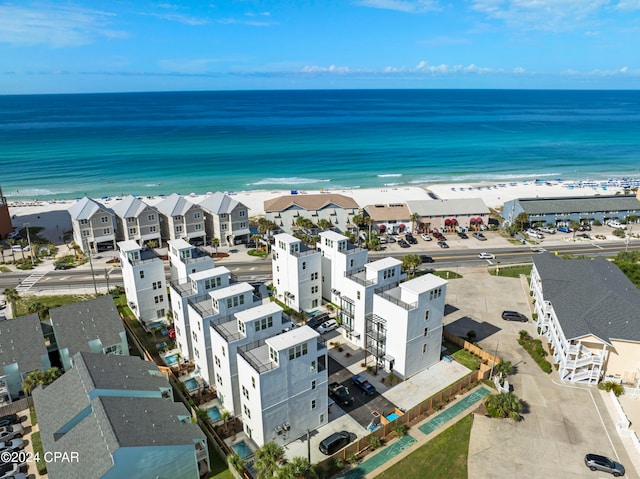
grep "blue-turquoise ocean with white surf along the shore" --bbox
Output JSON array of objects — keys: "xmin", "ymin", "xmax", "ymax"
[{"xmin": 0, "ymin": 90, "xmax": 640, "ymax": 200}]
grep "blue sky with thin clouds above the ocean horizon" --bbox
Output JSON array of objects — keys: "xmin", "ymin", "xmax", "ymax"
[{"xmin": 0, "ymin": 0, "xmax": 640, "ymax": 94}]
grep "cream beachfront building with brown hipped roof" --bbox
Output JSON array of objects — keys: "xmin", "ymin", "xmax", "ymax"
[{"xmin": 264, "ymin": 193, "xmax": 358, "ymax": 234}]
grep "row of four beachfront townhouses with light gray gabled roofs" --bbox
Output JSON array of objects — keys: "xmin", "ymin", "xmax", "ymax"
[{"xmin": 68, "ymin": 192, "xmax": 250, "ymax": 252}]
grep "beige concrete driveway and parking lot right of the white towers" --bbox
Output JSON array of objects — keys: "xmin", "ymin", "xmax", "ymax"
[{"xmin": 445, "ymin": 268, "xmax": 638, "ymax": 479}]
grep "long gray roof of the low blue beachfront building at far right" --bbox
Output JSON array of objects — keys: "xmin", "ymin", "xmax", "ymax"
[{"xmin": 518, "ymin": 195, "xmax": 640, "ymax": 215}]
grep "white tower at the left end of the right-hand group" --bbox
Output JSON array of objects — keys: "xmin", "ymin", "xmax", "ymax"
[{"xmin": 272, "ymin": 233, "xmax": 322, "ymax": 311}]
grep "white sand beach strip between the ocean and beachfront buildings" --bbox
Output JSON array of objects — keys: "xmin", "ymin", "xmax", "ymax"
[{"xmin": 9, "ymin": 181, "xmax": 623, "ymax": 248}]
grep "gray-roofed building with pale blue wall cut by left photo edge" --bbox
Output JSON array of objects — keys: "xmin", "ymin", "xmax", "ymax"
[{"xmin": 0, "ymin": 314, "xmax": 51, "ymax": 407}]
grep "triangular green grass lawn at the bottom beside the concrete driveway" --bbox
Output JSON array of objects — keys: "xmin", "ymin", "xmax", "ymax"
[{"xmin": 376, "ymin": 414, "xmax": 473, "ymax": 479}]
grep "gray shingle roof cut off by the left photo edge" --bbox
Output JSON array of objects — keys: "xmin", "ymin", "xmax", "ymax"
[{"xmin": 0, "ymin": 314, "xmax": 47, "ymax": 373}]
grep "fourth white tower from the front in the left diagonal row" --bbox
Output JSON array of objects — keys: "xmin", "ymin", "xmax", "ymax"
[{"xmin": 169, "ymin": 266, "xmax": 231, "ymax": 361}]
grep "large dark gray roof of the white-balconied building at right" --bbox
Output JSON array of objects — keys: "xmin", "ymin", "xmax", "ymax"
[{"xmin": 533, "ymin": 254, "xmax": 640, "ymax": 343}]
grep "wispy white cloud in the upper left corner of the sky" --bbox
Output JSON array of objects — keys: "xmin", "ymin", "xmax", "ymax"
[{"xmin": 0, "ymin": 5, "xmax": 128, "ymax": 48}]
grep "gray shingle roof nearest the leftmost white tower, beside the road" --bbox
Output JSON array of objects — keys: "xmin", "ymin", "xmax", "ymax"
[{"xmin": 49, "ymin": 295, "xmax": 124, "ymax": 356}]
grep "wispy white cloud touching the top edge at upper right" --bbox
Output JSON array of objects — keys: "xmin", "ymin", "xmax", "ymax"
[{"xmin": 471, "ymin": 0, "xmax": 612, "ymax": 31}]
